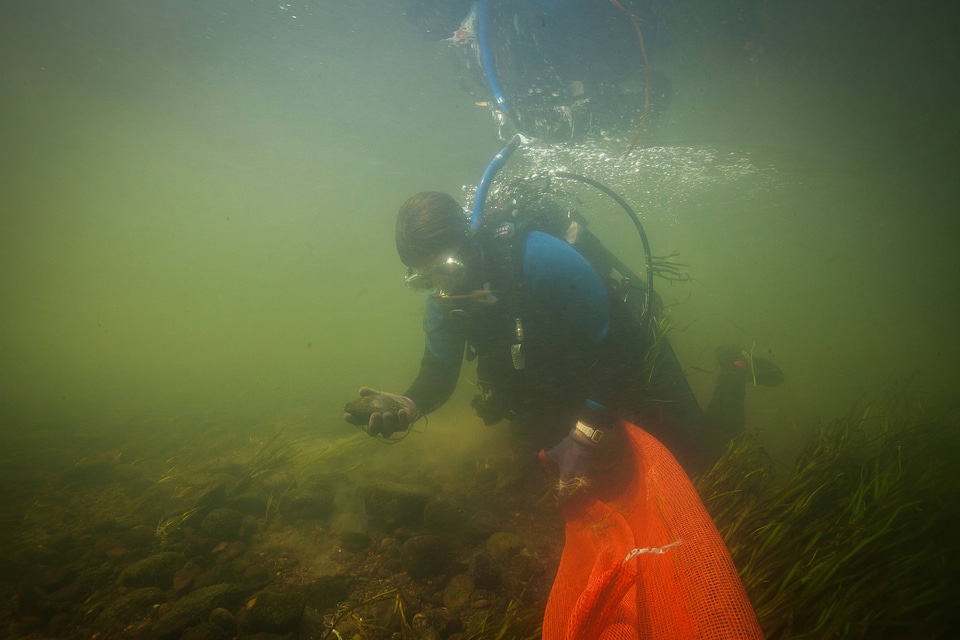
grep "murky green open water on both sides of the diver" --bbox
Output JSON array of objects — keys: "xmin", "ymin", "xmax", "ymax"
[{"xmin": 0, "ymin": 2, "xmax": 958, "ymax": 462}]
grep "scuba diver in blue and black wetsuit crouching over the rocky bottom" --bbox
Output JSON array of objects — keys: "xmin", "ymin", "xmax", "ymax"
[{"xmin": 344, "ymin": 174, "xmax": 783, "ymax": 487}]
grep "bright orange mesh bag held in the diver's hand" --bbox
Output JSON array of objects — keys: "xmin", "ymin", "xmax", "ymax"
[{"xmin": 543, "ymin": 423, "xmax": 763, "ymax": 640}]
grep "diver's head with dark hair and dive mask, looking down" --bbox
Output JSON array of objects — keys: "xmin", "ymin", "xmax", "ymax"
[{"xmin": 397, "ymin": 191, "xmax": 470, "ymax": 293}]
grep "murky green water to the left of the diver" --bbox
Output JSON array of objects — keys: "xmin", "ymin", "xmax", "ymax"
[{"xmin": 0, "ymin": 3, "xmax": 497, "ymax": 442}]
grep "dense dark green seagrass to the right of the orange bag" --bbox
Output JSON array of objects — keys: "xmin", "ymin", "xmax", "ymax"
[{"xmin": 697, "ymin": 388, "xmax": 960, "ymax": 639}]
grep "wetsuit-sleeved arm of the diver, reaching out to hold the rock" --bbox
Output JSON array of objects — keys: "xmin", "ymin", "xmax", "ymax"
[{"xmin": 403, "ymin": 299, "xmax": 465, "ymax": 413}]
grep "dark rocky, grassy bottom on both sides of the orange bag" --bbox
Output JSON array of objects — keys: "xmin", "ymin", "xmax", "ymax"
[{"xmin": 0, "ymin": 382, "xmax": 960, "ymax": 640}]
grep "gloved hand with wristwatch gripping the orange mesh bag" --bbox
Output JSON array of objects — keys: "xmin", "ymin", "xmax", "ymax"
[{"xmin": 539, "ymin": 400, "xmax": 623, "ymax": 498}]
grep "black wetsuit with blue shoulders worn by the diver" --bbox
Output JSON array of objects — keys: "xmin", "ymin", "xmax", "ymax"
[{"xmin": 404, "ymin": 231, "xmax": 705, "ymax": 468}]
